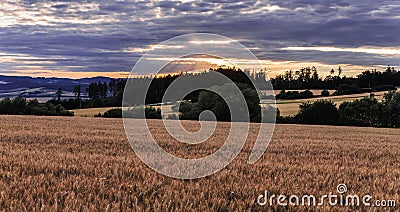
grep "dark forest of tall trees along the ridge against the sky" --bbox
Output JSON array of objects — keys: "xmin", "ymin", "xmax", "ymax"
[{"xmin": 52, "ymin": 67, "xmax": 400, "ymax": 109}]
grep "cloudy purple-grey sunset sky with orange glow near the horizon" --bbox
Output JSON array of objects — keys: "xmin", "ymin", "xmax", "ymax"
[{"xmin": 0, "ymin": 0, "xmax": 400, "ymax": 78}]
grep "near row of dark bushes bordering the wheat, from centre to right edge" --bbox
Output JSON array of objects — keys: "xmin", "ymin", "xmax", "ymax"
[{"xmin": 99, "ymin": 90, "xmax": 400, "ymax": 128}]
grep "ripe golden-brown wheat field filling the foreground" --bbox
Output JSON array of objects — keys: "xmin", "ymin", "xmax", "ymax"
[{"xmin": 0, "ymin": 116, "xmax": 400, "ymax": 211}]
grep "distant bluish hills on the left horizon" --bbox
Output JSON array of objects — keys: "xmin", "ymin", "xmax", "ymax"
[{"xmin": 0, "ymin": 76, "xmax": 112, "ymax": 100}]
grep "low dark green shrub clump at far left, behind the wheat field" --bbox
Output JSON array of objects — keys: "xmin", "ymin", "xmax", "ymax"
[{"xmin": 0, "ymin": 97, "xmax": 74, "ymax": 116}]
